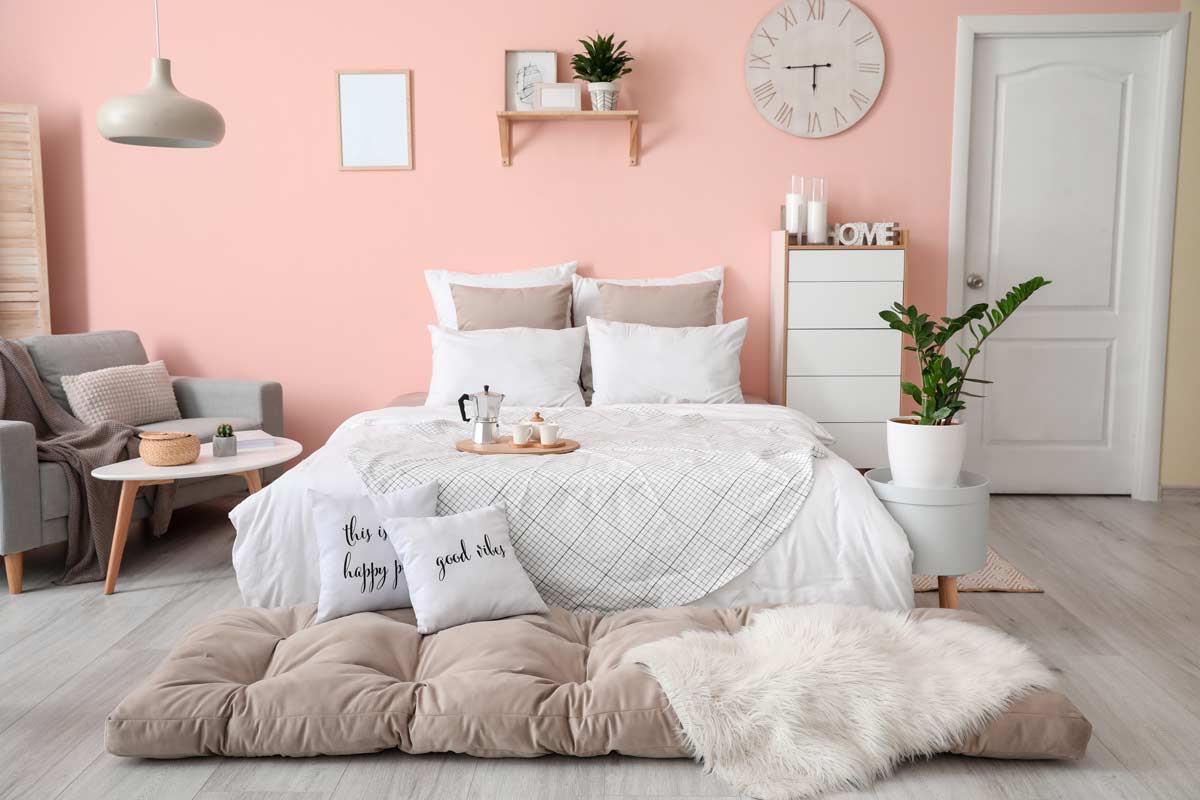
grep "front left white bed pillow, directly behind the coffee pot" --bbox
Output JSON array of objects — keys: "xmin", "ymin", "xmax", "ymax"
[{"xmin": 425, "ymin": 325, "xmax": 583, "ymax": 405}]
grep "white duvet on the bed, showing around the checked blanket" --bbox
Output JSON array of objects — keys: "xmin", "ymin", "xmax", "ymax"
[{"xmin": 229, "ymin": 404, "xmax": 913, "ymax": 609}]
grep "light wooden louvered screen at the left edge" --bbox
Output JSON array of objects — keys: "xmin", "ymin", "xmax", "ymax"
[{"xmin": 0, "ymin": 103, "xmax": 50, "ymax": 339}]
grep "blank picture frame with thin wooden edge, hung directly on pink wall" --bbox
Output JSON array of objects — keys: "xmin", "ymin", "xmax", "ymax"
[{"xmin": 337, "ymin": 70, "xmax": 413, "ymax": 170}]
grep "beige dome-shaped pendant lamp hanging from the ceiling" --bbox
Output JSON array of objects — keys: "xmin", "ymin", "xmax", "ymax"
[{"xmin": 96, "ymin": 0, "xmax": 224, "ymax": 148}]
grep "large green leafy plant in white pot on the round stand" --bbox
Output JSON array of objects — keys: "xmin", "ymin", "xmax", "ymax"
[{"xmin": 880, "ymin": 276, "xmax": 1050, "ymax": 488}]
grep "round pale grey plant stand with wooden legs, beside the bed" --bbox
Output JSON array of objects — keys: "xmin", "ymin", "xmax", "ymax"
[{"xmin": 866, "ymin": 469, "xmax": 990, "ymax": 608}]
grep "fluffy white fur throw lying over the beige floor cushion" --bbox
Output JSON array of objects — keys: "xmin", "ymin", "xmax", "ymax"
[{"xmin": 625, "ymin": 606, "xmax": 1052, "ymax": 799}]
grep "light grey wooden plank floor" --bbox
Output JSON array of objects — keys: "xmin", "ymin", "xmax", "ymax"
[{"xmin": 0, "ymin": 497, "xmax": 1200, "ymax": 800}]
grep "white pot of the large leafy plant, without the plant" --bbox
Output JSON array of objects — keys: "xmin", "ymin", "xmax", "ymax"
[{"xmin": 888, "ymin": 416, "xmax": 967, "ymax": 489}]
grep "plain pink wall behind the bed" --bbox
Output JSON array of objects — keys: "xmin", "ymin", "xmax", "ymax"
[{"xmin": 0, "ymin": 0, "xmax": 1178, "ymax": 446}]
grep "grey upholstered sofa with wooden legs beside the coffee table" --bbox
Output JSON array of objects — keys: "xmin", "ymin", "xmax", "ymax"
[{"xmin": 0, "ymin": 331, "xmax": 283, "ymax": 594}]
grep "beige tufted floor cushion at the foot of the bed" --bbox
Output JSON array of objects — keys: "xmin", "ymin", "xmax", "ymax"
[{"xmin": 104, "ymin": 606, "xmax": 1091, "ymax": 758}]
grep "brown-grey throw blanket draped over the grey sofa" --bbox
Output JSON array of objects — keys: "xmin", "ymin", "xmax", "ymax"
[{"xmin": 0, "ymin": 339, "xmax": 175, "ymax": 583}]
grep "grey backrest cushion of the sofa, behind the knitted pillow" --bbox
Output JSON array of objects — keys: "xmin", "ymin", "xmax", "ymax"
[{"xmin": 22, "ymin": 331, "xmax": 148, "ymax": 411}]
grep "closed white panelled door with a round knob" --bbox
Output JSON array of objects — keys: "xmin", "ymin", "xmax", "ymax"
[{"xmin": 948, "ymin": 18, "xmax": 1178, "ymax": 494}]
